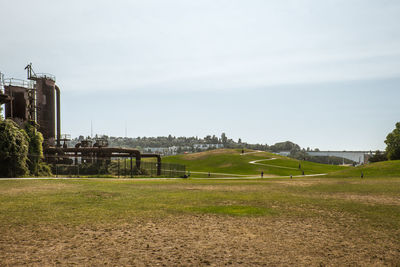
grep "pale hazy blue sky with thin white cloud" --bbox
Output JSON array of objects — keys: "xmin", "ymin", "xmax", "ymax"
[{"xmin": 0, "ymin": 0, "xmax": 400, "ymax": 150}]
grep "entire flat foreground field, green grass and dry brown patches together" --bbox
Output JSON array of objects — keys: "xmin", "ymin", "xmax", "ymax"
[{"xmin": 0, "ymin": 177, "xmax": 400, "ymax": 266}]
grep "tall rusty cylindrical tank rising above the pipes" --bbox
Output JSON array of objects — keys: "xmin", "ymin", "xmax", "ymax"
[{"xmin": 36, "ymin": 78, "xmax": 55, "ymax": 146}]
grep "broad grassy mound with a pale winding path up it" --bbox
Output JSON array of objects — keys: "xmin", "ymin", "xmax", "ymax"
[{"xmin": 163, "ymin": 149, "xmax": 346, "ymax": 176}]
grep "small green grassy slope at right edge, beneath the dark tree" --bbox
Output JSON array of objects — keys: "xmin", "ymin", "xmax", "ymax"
[{"xmin": 329, "ymin": 160, "xmax": 400, "ymax": 178}]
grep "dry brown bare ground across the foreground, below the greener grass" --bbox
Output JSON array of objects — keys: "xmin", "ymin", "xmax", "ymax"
[{"xmin": 0, "ymin": 214, "xmax": 400, "ymax": 266}]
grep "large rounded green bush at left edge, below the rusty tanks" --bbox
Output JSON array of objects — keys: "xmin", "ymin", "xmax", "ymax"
[{"xmin": 0, "ymin": 120, "xmax": 29, "ymax": 177}]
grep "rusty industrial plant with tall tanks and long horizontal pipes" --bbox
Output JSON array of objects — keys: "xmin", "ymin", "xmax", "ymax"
[{"xmin": 0, "ymin": 63, "xmax": 161, "ymax": 175}]
